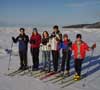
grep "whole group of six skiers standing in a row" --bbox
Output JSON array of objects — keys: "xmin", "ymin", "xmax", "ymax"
[{"xmin": 12, "ymin": 25, "xmax": 96, "ymax": 80}]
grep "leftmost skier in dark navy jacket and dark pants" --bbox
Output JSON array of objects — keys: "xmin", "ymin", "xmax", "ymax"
[{"xmin": 12, "ymin": 28, "xmax": 29, "ymax": 70}]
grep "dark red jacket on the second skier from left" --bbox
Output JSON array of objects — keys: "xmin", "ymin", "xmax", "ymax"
[{"xmin": 30, "ymin": 33, "xmax": 41, "ymax": 48}]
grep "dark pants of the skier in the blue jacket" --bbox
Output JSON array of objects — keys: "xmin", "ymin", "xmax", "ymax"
[{"xmin": 61, "ymin": 51, "xmax": 71, "ymax": 71}]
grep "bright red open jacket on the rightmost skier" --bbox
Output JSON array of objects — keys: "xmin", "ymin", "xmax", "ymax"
[{"xmin": 72, "ymin": 41, "xmax": 89, "ymax": 59}]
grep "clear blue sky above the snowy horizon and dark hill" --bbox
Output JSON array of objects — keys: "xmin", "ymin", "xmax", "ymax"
[{"xmin": 0, "ymin": 0, "xmax": 100, "ymax": 26}]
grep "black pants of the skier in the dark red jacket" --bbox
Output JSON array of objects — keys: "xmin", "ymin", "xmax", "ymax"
[{"xmin": 31, "ymin": 48, "xmax": 39, "ymax": 69}]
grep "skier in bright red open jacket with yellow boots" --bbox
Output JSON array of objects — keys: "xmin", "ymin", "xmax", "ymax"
[{"xmin": 72, "ymin": 34, "xmax": 96, "ymax": 80}]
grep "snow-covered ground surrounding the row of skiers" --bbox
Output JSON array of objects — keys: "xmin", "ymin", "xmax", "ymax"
[{"xmin": 0, "ymin": 27, "xmax": 100, "ymax": 90}]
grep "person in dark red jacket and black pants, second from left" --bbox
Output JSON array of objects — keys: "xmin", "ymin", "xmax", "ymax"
[{"xmin": 30, "ymin": 28, "xmax": 41, "ymax": 71}]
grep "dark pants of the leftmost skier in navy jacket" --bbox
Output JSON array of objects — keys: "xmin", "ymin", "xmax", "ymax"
[{"xmin": 19, "ymin": 51, "xmax": 27, "ymax": 67}]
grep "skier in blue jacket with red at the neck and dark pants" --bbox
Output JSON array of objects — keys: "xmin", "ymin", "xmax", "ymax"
[{"xmin": 60, "ymin": 34, "xmax": 72, "ymax": 76}]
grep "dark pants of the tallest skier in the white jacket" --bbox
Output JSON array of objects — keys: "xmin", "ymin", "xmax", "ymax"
[{"xmin": 52, "ymin": 50, "xmax": 59, "ymax": 72}]
